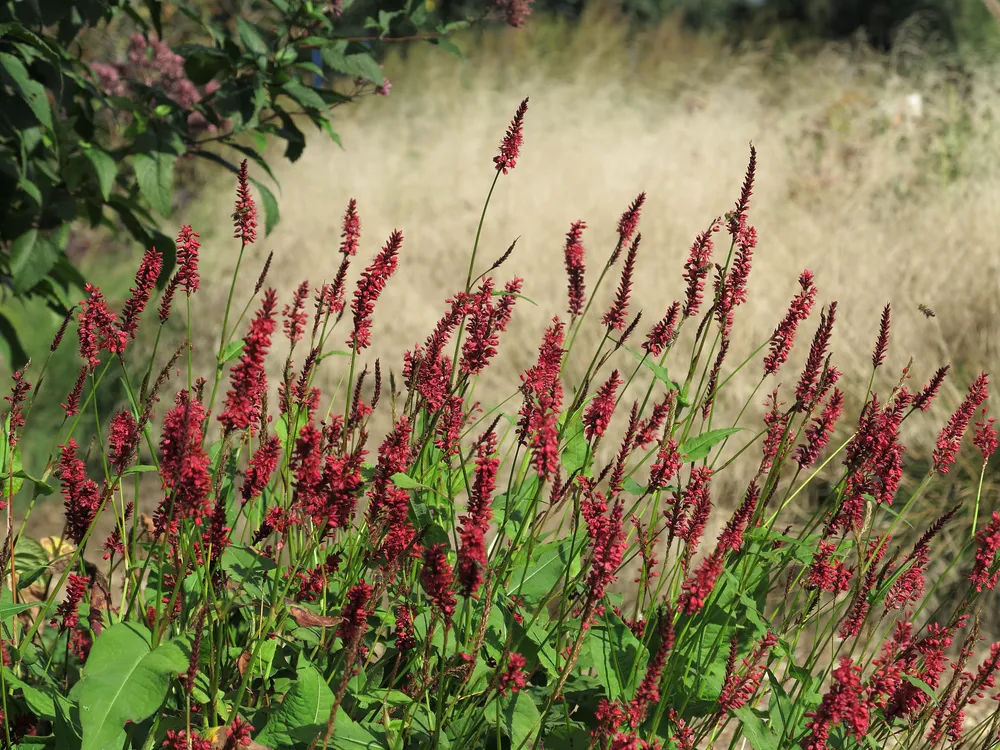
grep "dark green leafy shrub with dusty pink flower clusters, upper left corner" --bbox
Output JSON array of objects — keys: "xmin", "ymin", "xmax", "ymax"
[{"xmin": 0, "ymin": 0, "xmax": 478, "ymax": 367}]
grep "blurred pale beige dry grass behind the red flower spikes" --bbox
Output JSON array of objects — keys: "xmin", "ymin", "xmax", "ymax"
[{"xmin": 9, "ymin": 0, "xmax": 1000, "ymax": 600}]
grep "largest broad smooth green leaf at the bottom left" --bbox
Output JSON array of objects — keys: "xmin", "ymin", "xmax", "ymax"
[{"xmin": 70, "ymin": 623, "xmax": 190, "ymax": 750}]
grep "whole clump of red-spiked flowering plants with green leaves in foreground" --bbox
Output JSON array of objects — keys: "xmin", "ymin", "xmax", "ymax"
[{"xmin": 0, "ymin": 99, "xmax": 1000, "ymax": 750}]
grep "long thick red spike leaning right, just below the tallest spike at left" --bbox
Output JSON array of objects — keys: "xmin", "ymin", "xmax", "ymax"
[{"xmin": 219, "ymin": 289, "xmax": 277, "ymax": 435}]
